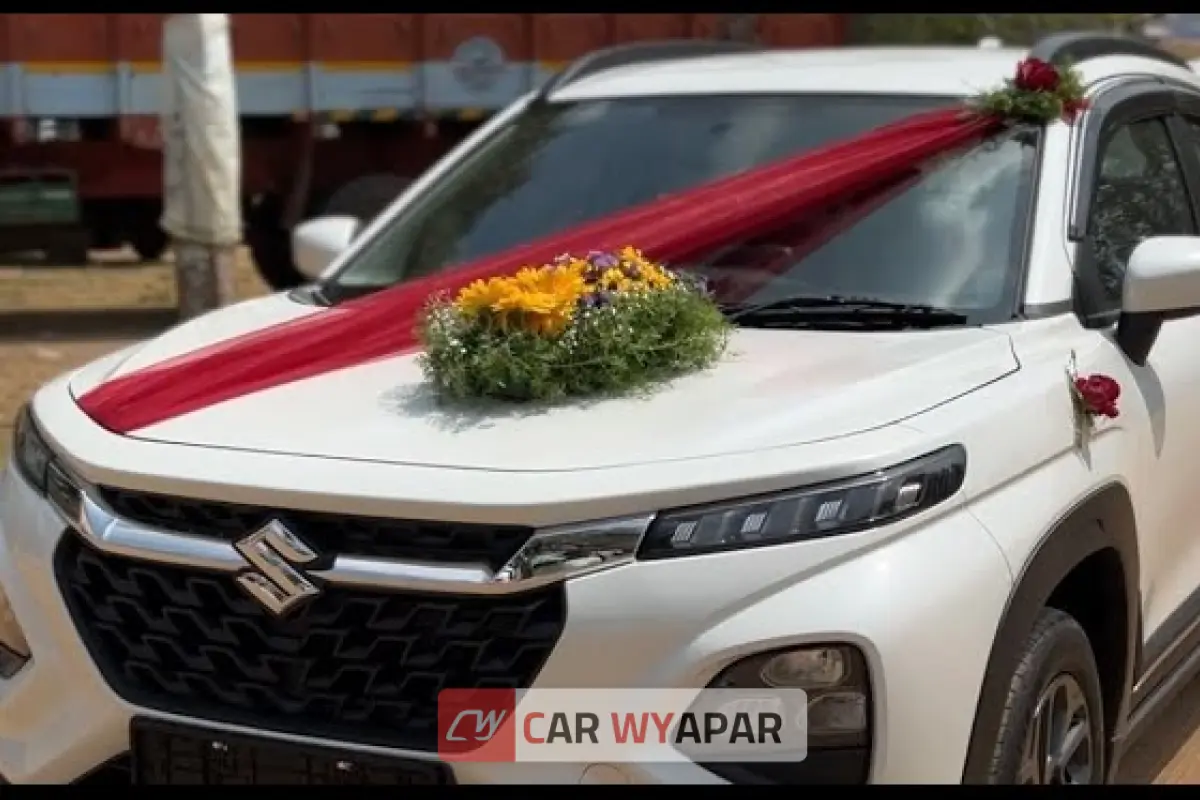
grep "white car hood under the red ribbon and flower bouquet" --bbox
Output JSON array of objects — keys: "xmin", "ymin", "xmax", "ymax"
[{"xmin": 72, "ymin": 296, "xmax": 1018, "ymax": 471}]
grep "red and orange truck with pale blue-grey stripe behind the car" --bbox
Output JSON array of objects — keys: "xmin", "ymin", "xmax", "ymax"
[{"xmin": 0, "ymin": 13, "xmax": 846, "ymax": 289}]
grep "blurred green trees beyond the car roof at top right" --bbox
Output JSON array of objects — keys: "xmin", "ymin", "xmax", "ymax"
[{"xmin": 850, "ymin": 14, "xmax": 1152, "ymax": 46}]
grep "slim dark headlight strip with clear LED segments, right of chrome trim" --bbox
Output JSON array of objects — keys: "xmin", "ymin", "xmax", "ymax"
[{"xmin": 637, "ymin": 445, "xmax": 967, "ymax": 559}]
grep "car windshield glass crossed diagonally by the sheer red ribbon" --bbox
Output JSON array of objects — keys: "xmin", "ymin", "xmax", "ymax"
[{"xmin": 323, "ymin": 95, "xmax": 1034, "ymax": 321}]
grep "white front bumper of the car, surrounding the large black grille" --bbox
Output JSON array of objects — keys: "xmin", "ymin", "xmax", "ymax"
[{"xmin": 0, "ymin": 470, "xmax": 1010, "ymax": 783}]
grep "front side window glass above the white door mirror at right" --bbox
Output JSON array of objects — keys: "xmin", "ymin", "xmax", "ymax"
[{"xmin": 1087, "ymin": 119, "xmax": 1195, "ymax": 312}]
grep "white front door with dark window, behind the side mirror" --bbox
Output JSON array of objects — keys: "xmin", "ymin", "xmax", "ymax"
[{"xmin": 1075, "ymin": 86, "xmax": 1200, "ymax": 671}]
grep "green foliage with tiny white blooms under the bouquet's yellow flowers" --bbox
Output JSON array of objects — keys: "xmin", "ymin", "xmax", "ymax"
[{"xmin": 420, "ymin": 281, "xmax": 730, "ymax": 402}]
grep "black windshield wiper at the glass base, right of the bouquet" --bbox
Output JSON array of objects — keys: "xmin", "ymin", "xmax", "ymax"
[{"xmin": 722, "ymin": 295, "xmax": 967, "ymax": 327}]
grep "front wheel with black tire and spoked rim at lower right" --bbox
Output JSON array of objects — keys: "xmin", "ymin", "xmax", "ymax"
[{"xmin": 988, "ymin": 608, "xmax": 1106, "ymax": 784}]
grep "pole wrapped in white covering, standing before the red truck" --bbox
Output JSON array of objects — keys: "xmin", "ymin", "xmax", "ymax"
[{"xmin": 162, "ymin": 14, "xmax": 241, "ymax": 319}]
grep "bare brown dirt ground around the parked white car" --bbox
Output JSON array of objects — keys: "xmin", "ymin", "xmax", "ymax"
[{"xmin": 0, "ymin": 255, "xmax": 1200, "ymax": 783}]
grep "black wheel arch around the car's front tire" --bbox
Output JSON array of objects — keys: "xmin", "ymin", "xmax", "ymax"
[{"xmin": 962, "ymin": 482, "xmax": 1140, "ymax": 784}]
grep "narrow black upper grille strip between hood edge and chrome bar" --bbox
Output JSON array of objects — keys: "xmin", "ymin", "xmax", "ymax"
[{"xmin": 100, "ymin": 487, "xmax": 533, "ymax": 571}]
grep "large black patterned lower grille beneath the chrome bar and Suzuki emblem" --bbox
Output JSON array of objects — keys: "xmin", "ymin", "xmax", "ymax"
[{"xmin": 55, "ymin": 533, "xmax": 566, "ymax": 750}]
